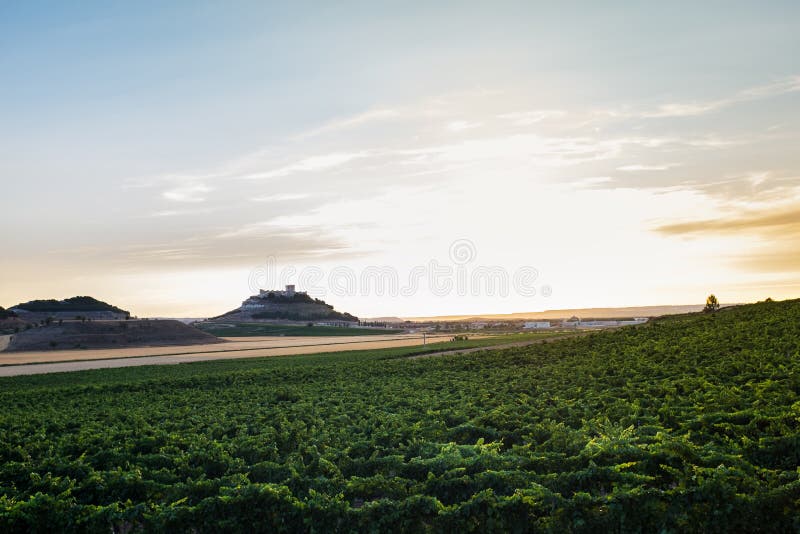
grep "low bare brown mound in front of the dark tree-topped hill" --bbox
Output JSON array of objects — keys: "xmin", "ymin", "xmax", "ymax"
[{"xmin": 6, "ymin": 320, "xmax": 221, "ymax": 351}]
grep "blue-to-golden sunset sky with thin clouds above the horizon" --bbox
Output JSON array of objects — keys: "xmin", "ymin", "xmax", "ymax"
[{"xmin": 0, "ymin": 1, "xmax": 800, "ymax": 317}]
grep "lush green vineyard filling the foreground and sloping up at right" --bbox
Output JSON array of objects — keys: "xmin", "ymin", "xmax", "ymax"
[{"xmin": 0, "ymin": 301, "xmax": 800, "ymax": 533}]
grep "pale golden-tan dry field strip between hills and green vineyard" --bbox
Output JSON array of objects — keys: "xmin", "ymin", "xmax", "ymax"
[{"xmin": 0, "ymin": 335, "xmax": 462, "ymax": 376}]
